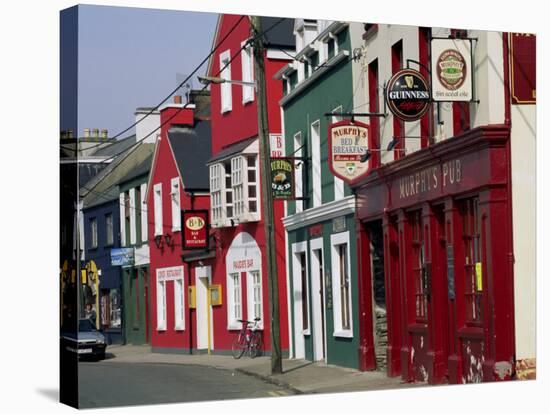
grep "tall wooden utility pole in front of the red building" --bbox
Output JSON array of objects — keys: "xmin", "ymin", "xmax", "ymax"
[{"xmin": 250, "ymin": 16, "xmax": 283, "ymax": 374}]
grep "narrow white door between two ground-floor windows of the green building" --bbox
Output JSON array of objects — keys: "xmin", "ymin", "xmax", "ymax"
[{"xmin": 310, "ymin": 238, "xmax": 326, "ymax": 361}]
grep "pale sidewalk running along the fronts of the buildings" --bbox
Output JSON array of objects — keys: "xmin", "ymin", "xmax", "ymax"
[{"xmin": 104, "ymin": 345, "xmax": 421, "ymax": 394}]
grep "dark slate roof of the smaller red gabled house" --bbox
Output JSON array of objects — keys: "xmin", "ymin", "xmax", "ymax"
[{"xmin": 168, "ymin": 120, "xmax": 212, "ymax": 191}]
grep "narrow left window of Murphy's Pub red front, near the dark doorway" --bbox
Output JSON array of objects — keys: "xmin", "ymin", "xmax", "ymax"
[{"xmin": 409, "ymin": 210, "xmax": 428, "ymax": 323}]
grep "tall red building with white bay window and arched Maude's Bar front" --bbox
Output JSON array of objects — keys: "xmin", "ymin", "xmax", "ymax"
[{"xmin": 204, "ymin": 15, "xmax": 294, "ymax": 351}]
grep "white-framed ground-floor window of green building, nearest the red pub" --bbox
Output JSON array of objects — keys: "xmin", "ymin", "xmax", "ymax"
[{"xmin": 331, "ymin": 232, "xmax": 353, "ymax": 338}]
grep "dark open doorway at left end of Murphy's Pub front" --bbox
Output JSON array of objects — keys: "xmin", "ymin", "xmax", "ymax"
[{"xmin": 367, "ymin": 220, "xmax": 388, "ymax": 370}]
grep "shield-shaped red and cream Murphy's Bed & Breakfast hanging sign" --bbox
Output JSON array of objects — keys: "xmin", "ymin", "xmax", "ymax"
[{"xmin": 328, "ymin": 120, "xmax": 369, "ymax": 184}]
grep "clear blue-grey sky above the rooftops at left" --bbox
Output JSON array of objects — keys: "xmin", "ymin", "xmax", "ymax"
[{"xmin": 74, "ymin": 5, "xmax": 217, "ymax": 137}]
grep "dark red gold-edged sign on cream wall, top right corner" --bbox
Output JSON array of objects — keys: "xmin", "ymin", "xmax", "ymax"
[{"xmin": 510, "ymin": 33, "xmax": 537, "ymax": 104}]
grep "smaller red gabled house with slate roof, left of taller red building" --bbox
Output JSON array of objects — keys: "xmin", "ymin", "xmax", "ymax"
[{"xmin": 146, "ymin": 91, "xmax": 216, "ymax": 351}]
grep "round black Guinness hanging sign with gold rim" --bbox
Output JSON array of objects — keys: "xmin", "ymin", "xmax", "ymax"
[{"xmin": 386, "ymin": 69, "xmax": 431, "ymax": 122}]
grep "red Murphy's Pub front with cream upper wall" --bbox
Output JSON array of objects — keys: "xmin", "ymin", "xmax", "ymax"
[{"xmin": 352, "ymin": 25, "xmax": 536, "ymax": 384}]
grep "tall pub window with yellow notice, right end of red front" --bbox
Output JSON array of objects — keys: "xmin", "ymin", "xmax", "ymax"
[{"xmin": 460, "ymin": 198, "xmax": 483, "ymax": 324}]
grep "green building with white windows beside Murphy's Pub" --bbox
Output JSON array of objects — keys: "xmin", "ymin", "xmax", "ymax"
[{"xmin": 275, "ymin": 19, "xmax": 363, "ymax": 368}]
